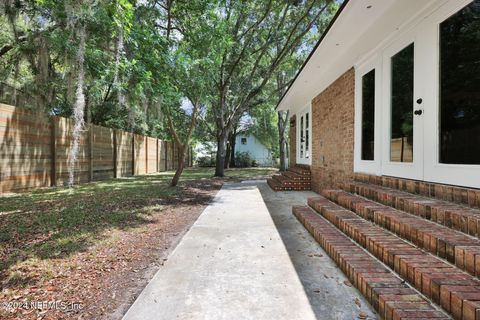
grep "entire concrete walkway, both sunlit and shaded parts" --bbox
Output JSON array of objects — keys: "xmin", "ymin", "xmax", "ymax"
[{"xmin": 124, "ymin": 182, "xmax": 376, "ymax": 320}]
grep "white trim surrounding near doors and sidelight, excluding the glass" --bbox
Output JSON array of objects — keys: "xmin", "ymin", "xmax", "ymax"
[{"xmin": 354, "ymin": 0, "xmax": 480, "ymax": 188}]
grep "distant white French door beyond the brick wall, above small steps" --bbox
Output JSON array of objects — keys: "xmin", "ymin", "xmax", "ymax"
[{"xmin": 297, "ymin": 106, "xmax": 312, "ymax": 165}]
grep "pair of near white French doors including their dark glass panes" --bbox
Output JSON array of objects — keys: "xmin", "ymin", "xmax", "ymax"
[{"xmin": 381, "ymin": 0, "xmax": 480, "ymax": 188}]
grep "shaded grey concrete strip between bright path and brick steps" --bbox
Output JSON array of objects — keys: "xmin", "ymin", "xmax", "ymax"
[{"xmin": 257, "ymin": 183, "xmax": 378, "ymax": 320}]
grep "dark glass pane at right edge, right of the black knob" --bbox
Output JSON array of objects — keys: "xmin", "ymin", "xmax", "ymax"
[{"xmin": 439, "ymin": 1, "xmax": 480, "ymax": 165}]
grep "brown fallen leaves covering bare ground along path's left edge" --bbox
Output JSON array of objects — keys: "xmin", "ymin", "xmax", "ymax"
[{"xmin": 0, "ymin": 175, "xmax": 222, "ymax": 320}]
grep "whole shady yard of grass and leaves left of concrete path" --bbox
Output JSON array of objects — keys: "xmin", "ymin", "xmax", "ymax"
[{"xmin": 0, "ymin": 169, "xmax": 273, "ymax": 319}]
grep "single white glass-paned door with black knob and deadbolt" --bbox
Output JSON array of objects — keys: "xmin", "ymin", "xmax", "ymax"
[{"xmin": 382, "ymin": 33, "xmax": 425, "ymax": 179}]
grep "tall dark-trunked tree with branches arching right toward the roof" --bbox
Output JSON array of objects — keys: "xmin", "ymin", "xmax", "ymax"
[{"xmin": 208, "ymin": 0, "xmax": 333, "ymax": 176}]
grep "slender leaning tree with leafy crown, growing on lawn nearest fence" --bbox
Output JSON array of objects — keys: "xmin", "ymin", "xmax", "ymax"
[{"xmin": 158, "ymin": 0, "xmax": 212, "ymax": 186}]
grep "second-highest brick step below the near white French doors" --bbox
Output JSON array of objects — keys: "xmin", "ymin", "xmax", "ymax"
[{"xmin": 347, "ymin": 182, "xmax": 480, "ymax": 238}]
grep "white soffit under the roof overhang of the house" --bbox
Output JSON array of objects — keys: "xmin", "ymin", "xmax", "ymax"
[{"xmin": 277, "ymin": 0, "xmax": 446, "ymax": 114}]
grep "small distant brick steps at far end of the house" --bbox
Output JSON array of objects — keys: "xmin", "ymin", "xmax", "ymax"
[{"xmin": 267, "ymin": 166, "xmax": 312, "ymax": 191}]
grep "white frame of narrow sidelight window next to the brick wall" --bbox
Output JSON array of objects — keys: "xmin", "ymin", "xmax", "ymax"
[{"xmin": 354, "ymin": 55, "xmax": 383, "ymax": 175}]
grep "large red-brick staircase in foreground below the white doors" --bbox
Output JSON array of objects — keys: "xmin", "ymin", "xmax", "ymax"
[{"xmin": 293, "ymin": 179, "xmax": 480, "ymax": 320}]
